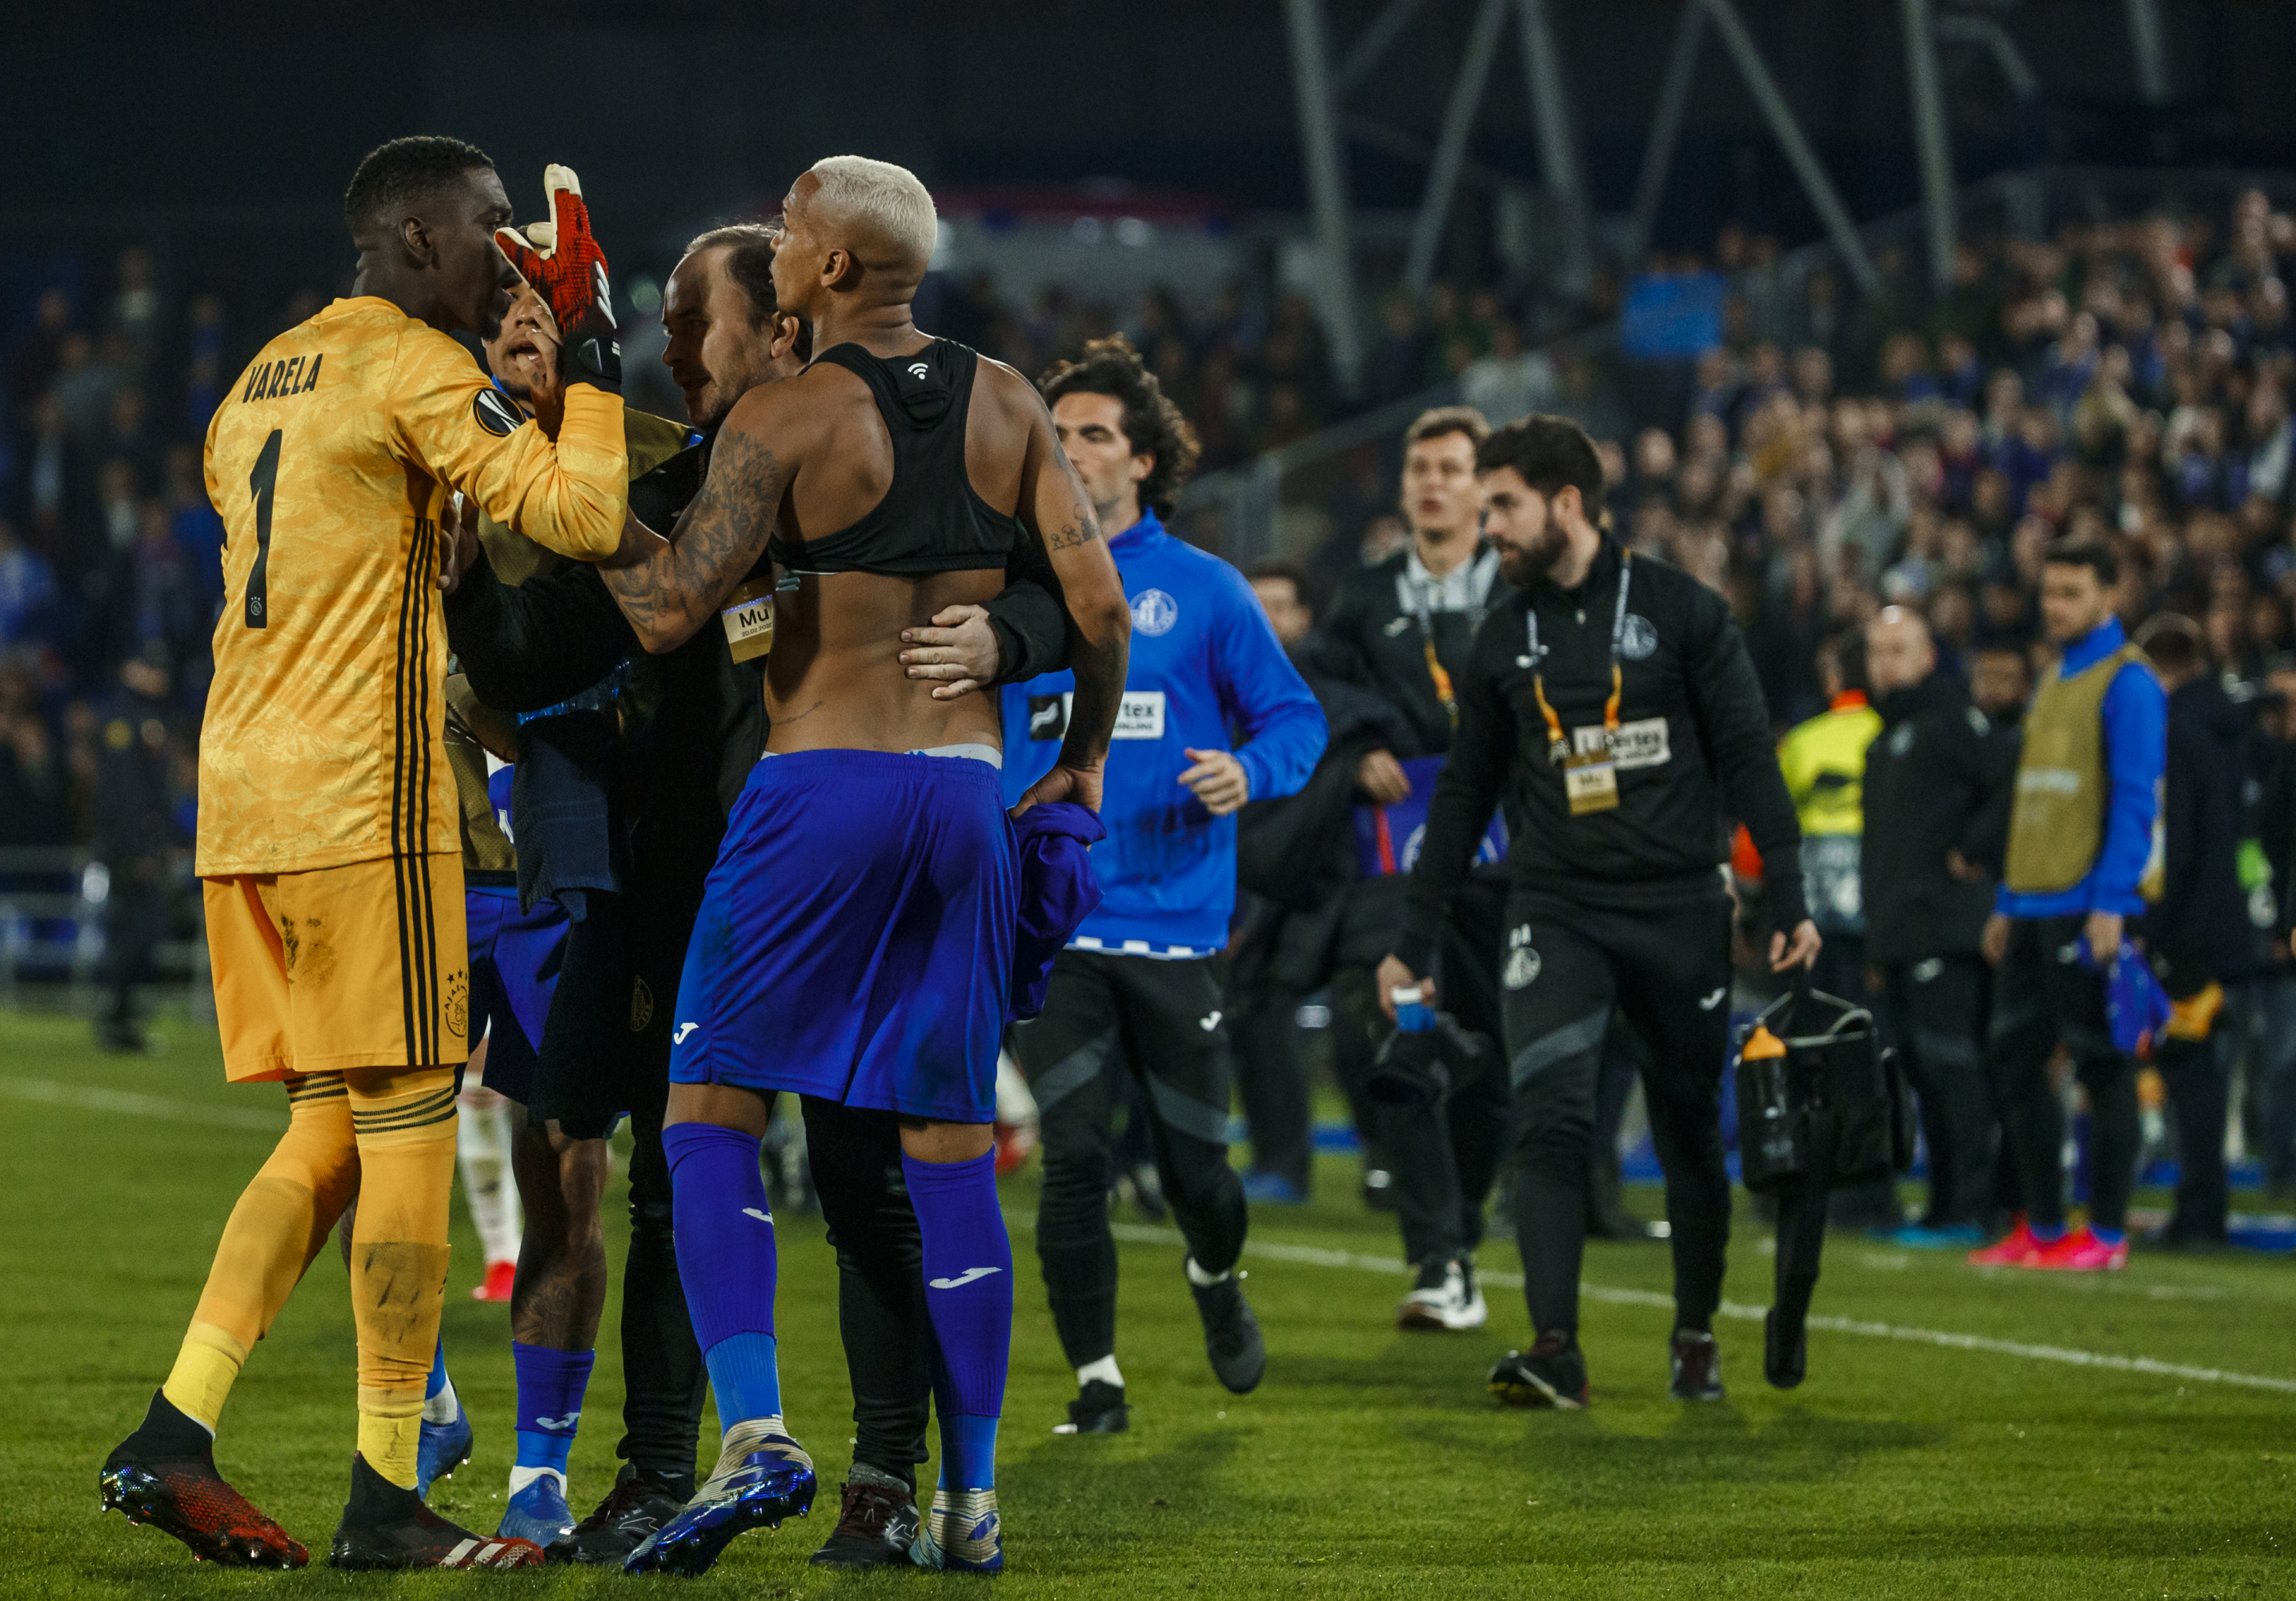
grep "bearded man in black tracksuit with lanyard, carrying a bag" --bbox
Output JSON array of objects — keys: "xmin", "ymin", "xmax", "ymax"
[{"xmin": 1380, "ymin": 415, "xmax": 1818, "ymax": 1408}]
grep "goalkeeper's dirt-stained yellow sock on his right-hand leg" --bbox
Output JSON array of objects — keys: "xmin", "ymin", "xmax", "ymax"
[{"xmin": 347, "ymin": 1068, "xmax": 455, "ymax": 1488}]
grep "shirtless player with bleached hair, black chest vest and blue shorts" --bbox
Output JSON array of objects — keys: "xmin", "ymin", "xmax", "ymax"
[{"xmin": 606, "ymin": 156, "xmax": 1132, "ymax": 1574}]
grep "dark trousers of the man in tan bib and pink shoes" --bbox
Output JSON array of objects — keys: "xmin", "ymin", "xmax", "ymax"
[{"xmin": 1986, "ymin": 917, "xmax": 2142, "ymax": 1229}]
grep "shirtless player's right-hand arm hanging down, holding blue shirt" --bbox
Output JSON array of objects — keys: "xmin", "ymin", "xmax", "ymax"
[{"xmin": 1015, "ymin": 374, "xmax": 1132, "ymax": 811}]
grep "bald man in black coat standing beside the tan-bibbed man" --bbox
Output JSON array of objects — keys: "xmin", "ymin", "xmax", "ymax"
[{"xmin": 1862, "ymin": 607, "xmax": 2016, "ymax": 1250}]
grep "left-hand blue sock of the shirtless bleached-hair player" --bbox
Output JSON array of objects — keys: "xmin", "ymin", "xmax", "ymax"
[{"xmin": 661, "ymin": 1123, "xmax": 780, "ymax": 1429}]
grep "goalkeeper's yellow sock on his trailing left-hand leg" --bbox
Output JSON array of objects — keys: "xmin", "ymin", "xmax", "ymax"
[{"xmin": 161, "ymin": 1073, "xmax": 359, "ymax": 1431}]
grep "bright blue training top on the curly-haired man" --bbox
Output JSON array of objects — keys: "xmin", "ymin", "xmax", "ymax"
[{"xmin": 1004, "ymin": 512, "xmax": 1324, "ymax": 958}]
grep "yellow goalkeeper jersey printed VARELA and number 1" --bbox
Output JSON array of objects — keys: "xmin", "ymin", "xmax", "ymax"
[{"xmin": 198, "ymin": 296, "xmax": 627, "ymax": 877}]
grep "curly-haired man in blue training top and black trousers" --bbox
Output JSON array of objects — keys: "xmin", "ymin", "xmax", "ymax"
[{"xmin": 1004, "ymin": 335, "xmax": 1324, "ymax": 1434}]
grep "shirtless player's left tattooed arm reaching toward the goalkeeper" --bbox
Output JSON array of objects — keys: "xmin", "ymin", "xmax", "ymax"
[{"xmin": 599, "ymin": 391, "xmax": 790, "ymax": 652}]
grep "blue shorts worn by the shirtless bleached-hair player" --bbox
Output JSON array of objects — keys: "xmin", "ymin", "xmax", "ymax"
[{"xmin": 671, "ymin": 751, "xmax": 1020, "ymax": 1123}]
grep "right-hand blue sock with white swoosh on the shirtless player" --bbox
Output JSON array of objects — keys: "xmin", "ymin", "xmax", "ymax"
[{"xmin": 900, "ymin": 1151, "xmax": 1012, "ymax": 1491}]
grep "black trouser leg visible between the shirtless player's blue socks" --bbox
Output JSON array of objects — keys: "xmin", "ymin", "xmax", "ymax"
[{"xmin": 799, "ymin": 1096, "xmax": 939, "ymax": 1488}]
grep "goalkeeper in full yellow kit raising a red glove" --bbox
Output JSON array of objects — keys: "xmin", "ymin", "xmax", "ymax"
[{"xmin": 101, "ymin": 138, "xmax": 627, "ymax": 1569}]
